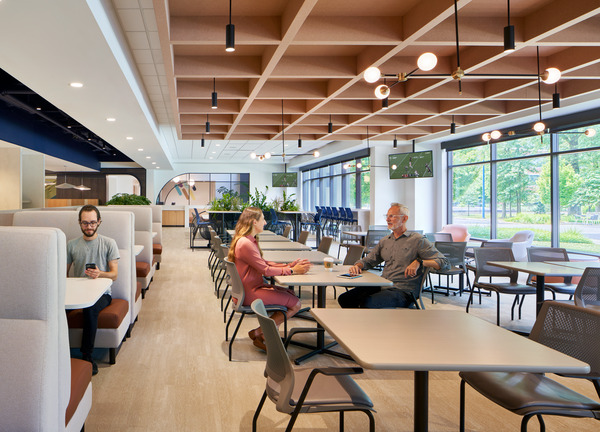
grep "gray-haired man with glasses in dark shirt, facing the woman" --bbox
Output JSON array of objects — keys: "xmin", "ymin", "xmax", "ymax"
[{"xmin": 338, "ymin": 203, "xmax": 450, "ymax": 309}]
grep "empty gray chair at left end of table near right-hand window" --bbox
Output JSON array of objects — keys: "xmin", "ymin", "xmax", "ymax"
[{"xmin": 467, "ymin": 248, "xmax": 536, "ymax": 325}]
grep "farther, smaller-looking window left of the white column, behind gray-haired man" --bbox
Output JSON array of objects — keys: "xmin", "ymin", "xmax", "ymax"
[{"xmin": 302, "ymin": 156, "xmax": 371, "ymax": 210}]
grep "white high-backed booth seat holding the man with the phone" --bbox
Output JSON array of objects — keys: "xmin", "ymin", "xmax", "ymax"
[{"xmin": 13, "ymin": 209, "xmax": 133, "ymax": 364}]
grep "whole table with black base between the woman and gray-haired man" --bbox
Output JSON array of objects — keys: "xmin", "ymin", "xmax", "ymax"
[{"xmin": 275, "ymin": 265, "xmax": 393, "ymax": 364}]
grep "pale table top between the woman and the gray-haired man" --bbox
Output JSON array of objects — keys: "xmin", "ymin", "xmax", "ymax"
[{"xmin": 275, "ymin": 265, "xmax": 393, "ymax": 287}]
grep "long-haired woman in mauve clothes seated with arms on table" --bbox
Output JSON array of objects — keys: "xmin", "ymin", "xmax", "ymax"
[{"xmin": 227, "ymin": 207, "xmax": 310, "ymax": 351}]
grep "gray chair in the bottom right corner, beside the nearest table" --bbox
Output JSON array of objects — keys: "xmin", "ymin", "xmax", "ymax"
[{"xmin": 459, "ymin": 301, "xmax": 600, "ymax": 432}]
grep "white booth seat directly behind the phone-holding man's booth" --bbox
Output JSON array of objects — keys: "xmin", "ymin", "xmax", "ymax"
[{"xmin": 107, "ymin": 205, "xmax": 155, "ymax": 291}]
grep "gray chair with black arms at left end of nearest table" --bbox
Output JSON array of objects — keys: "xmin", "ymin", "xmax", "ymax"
[{"xmin": 252, "ymin": 299, "xmax": 375, "ymax": 432}]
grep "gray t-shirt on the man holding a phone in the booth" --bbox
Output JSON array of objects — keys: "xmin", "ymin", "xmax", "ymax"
[{"xmin": 67, "ymin": 234, "xmax": 120, "ymax": 294}]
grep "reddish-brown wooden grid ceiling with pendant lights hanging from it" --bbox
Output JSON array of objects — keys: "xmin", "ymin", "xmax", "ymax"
[{"xmin": 154, "ymin": 0, "xmax": 600, "ymax": 141}]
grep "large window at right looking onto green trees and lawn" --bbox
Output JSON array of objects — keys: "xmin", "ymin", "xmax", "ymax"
[{"xmin": 448, "ymin": 126, "xmax": 600, "ymax": 254}]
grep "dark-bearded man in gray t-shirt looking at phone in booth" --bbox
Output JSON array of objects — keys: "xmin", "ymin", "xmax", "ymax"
[{"xmin": 67, "ymin": 205, "xmax": 120, "ymax": 375}]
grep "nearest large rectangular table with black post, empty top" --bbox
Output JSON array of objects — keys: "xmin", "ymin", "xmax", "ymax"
[{"xmin": 311, "ymin": 309, "xmax": 589, "ymax": 432}]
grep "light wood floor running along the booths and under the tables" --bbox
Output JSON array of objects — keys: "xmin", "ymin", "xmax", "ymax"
[{"xmin": 86, "ymin": 228, "xmax": 600, "ymax": 432}]
